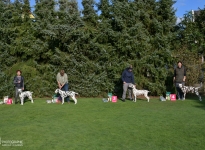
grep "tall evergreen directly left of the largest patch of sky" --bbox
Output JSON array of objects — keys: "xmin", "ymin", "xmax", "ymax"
[{"xmin": 146, "ymin": 0, "xmax": 176, "ymax": 94}]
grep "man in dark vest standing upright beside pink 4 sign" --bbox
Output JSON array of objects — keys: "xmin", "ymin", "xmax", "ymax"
[{"xmin": 173, "ymin": 61, "xmax": 186, "ymax": 100}]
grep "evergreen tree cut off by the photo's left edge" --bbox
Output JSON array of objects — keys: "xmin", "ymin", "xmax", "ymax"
[{"xmin": 0, "ymin": 0, "xmax": 21, "ymax": 96}]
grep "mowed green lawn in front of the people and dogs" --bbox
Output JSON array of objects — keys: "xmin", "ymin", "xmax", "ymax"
[{"xmin": 0, "ymin": 97, "xmax": 205, "ymax": 150}]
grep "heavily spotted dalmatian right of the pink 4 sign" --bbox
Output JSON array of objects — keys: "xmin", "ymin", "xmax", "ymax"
[{"xmin": 179, "ymin": 83, "xmax": 202, "ymax": 101}]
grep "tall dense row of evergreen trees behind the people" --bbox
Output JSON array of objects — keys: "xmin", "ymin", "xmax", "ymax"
[{"xmin": 0, "ymin": 0, "xmax": 204, "ymax": 97}]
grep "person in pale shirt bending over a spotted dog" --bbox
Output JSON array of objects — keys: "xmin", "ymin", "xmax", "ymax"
[{"xmin": 56, "ymin": 69, "xmax": 70, "ymax": 103}]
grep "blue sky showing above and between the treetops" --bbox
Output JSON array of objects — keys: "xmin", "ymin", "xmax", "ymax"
[{"xmin": 27, "ymin": 0, "xmax": 205, "ymax": 18}]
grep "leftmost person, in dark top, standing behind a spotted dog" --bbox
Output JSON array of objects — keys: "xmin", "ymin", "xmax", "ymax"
[{"xmin": 13, "ymin": 70, "xmax": 24, "ymax": 104}]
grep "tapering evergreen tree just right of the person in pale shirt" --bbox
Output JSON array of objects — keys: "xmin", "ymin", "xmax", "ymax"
[{"xmin": 72, "ymin": 1, "xmax": 113, "ymax": 96}]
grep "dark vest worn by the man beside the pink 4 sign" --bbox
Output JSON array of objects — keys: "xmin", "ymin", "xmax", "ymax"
[{"xmin": 174, "ymin": 66, "xmax": 186, "ymax": 83}]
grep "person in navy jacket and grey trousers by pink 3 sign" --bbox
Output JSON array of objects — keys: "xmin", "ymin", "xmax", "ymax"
[{"xmin": 122, "ymin": 65, "xmax": 135, "ymax": 102}]
